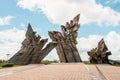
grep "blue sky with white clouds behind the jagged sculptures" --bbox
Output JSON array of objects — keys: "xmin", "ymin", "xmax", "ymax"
[{"xmin": 0, "ymin": 0, "xmax": 120, "ymax": 60}]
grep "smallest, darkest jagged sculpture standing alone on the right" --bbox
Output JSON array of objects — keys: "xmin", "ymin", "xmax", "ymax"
[{"xmin": 87, "ymin": 39, "xmax": 111, "ymax": 64}]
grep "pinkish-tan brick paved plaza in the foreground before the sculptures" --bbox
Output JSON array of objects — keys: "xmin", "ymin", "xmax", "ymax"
[{"xmin": 0, "ymin": 63, "xmax": 120, "ymax": 80}]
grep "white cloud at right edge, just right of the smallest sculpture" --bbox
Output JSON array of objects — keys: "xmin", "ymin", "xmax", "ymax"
[{"xmin": 106, "ymin": 31, "xmax": 120, "ymax": 60}]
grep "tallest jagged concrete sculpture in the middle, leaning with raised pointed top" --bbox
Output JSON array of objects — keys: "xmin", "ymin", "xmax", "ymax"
[{"xmin": 49, "ymin": 14, "xmax": 82, "ymax": 62}]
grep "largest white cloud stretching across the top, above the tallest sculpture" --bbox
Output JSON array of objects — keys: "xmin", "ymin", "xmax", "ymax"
[{"xmin": 17, "ymin": 0, "xmax": 120, "ymax": 26}]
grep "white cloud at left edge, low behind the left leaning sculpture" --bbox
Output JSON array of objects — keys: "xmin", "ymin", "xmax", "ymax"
[{"xmin": 0, "ymin": 28, "xmax": 25, "ymax": 59}]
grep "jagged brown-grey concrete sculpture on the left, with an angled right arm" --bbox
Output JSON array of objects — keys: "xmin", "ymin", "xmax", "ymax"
[{"xmin": 9, "ymin": 24, "xmax": 57, "ymax": 64}]
